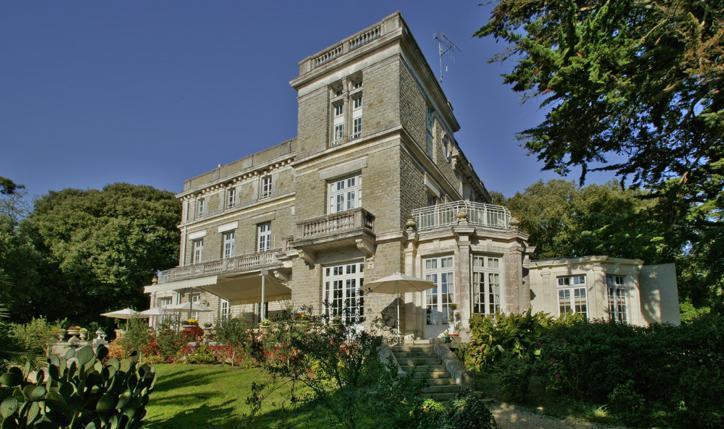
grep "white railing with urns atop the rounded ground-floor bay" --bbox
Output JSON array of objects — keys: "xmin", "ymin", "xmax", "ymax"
[{"xmin": 412, "ymin": 201, "xmax": 511, "ymax": 231}]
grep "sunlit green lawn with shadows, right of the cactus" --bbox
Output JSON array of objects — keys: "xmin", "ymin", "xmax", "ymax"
[{"xmin": 145, "ymin": 364, "xmax": 335, "ymax": 429}]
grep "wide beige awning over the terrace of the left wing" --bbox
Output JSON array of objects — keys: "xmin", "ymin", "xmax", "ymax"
[{"xmin": 199, "ymin": 273, "xmax": 292, "ymax": 305}]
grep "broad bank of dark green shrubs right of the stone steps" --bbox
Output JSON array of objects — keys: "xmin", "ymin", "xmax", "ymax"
[{"xmin": 465, "ymin": 314, "xmax": 724, "ymax": 428}]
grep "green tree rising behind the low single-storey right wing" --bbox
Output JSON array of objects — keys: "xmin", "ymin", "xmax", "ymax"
[{"xmin": 506, "ymin": 180, "xmax": 668, "ymax": 264}]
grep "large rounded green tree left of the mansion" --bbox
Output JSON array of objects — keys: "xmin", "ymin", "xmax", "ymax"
[{"xmin": 17, "ymin": 184, "xmax": 180, "ymax": 322}]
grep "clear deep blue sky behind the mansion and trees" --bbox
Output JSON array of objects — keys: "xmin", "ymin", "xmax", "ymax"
[{"xmin": 0, "ymin": 0, "xmax": 607, "ymax": 201}]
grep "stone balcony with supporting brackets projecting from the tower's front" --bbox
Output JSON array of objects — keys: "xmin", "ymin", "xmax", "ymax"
[{"xmin": 292, "ymin": 208, "xmax": 375, "ymax": 255}]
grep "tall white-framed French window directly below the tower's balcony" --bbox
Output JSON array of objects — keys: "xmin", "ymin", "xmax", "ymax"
[{"xmin": 322, "ymin": 262, "xmax": 364, "ymax": 323}]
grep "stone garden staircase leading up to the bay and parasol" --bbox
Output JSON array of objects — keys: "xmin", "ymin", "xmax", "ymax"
[{"xmin": 391, "ymin": 341, "xmax": 460, "ymax": 401}]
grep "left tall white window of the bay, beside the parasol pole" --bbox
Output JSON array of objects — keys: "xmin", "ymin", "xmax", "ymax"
[{"xmin": 423, "ymin": 256, "xmax": 455, "ymax": 325}]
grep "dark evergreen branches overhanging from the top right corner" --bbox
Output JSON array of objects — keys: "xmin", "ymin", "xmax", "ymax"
[{"xmin": 476, "ymin": 0, "xmax": 724, "ymax": 310}]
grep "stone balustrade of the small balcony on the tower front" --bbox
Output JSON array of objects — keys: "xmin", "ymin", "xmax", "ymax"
[{"xmin": 295, "ymin": 208, "xmax": 375, "ymax": 240}]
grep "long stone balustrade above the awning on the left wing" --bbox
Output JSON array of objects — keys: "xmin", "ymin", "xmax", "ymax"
[{"xmin": 158, "ymin": 249, "xmax": 279, "ymax": 284}]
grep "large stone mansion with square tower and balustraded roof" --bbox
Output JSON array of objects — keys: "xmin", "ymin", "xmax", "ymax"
[{"xmin": 145, "ymin": 13, "xmax": 678, "ymax": 338}]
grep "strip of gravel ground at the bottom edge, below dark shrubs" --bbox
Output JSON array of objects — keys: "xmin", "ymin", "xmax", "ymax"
[{"xmin": 490, "ymin": 402, "xmax": 623, "ymax": 429}]
